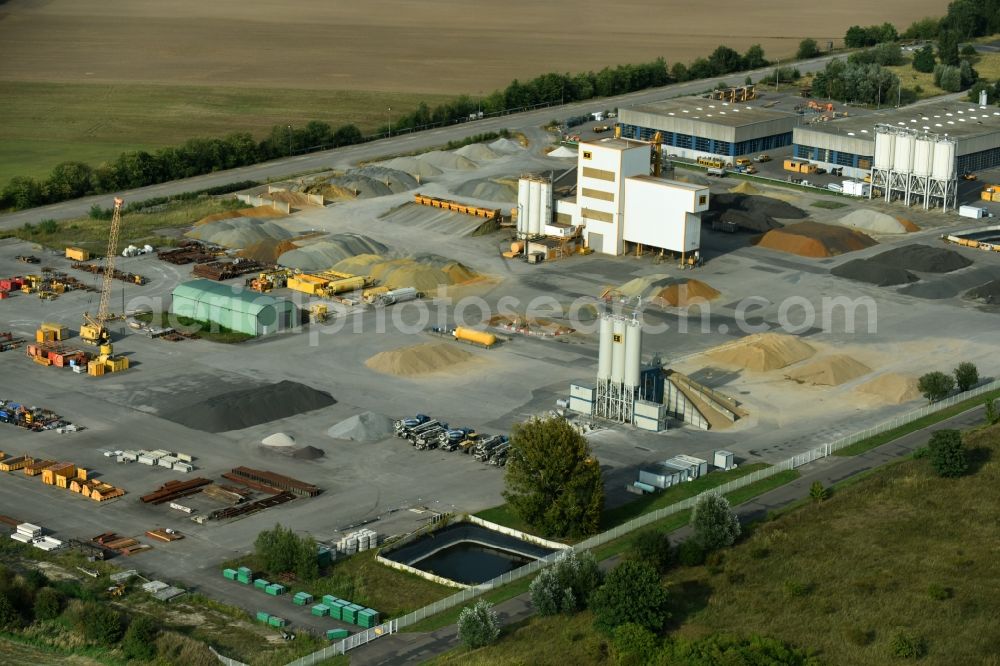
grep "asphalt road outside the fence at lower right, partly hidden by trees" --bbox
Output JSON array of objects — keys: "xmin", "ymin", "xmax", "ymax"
[{"xmin": 349, "ymin": 400, "xmax": 984, "ymax": 666}]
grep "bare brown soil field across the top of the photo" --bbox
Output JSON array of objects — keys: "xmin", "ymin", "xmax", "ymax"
[{"xmin": 0, "ymin": 0, "xmax": 948, "ymax": 95}]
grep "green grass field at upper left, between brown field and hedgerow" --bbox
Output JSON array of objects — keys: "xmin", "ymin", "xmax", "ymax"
[{"xmin": 0, "ymin": 81, "xmax": 450, "ymax": 187}]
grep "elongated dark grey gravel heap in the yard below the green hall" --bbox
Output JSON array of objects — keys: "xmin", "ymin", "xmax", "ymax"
[{"xmin": 160, "ymin": 381, "xmax": 337, "ymax": 432}]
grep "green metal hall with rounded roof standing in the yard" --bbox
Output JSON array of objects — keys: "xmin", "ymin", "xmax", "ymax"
[{"xmin": 170, "ymin": 280, "xmax": 298, "ymax": 335}]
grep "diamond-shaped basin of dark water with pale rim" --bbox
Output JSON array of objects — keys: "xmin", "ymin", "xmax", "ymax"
[{"xmin": 382, "ymin": 523, "xmax": 554, "ymax": 585}]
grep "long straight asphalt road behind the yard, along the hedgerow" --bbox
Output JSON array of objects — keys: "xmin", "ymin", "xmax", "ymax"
[{"xmin": 0, "ymin": 56, "xmax": 837, "ymax": 229}]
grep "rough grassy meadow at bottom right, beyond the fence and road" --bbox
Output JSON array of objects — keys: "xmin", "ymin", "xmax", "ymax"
[{"xmin": 434, "ymin": 426, "xmax": 1000, "ymax": 666}]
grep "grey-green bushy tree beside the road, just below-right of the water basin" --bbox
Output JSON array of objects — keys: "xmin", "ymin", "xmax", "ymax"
[{"xmin": 528, "ymin": 549, "xmax": 601, "ymax": 615}]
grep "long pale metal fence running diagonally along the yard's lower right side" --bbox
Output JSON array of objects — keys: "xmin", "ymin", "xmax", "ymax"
[{"xmin": 276, "ymin": 380, "xmax": 1000, "ymax": 666}]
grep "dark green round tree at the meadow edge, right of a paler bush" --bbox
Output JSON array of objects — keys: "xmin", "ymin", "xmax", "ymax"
[{"xmin": 590, "ymin": 560, "xmax": 670, "ymax": 633}]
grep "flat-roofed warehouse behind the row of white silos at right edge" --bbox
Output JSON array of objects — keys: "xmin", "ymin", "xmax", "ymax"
[{"xmin": 793, "ymin": 99, "xmax": 1000, "ymax": 178}]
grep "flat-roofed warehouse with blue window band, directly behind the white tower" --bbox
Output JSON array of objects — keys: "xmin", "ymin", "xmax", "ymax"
[{"xmin": 618, "ymin": 97, "xmax": 799, "ymax": 162}]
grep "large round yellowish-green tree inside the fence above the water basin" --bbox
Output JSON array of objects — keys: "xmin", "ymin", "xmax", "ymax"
[{"xmin": 504, "ymin": 417, "xmax": 604, "ymax": 536}]
